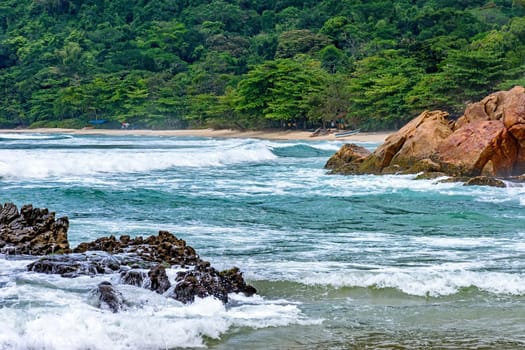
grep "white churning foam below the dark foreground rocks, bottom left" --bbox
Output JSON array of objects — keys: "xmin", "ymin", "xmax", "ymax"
[{"xmin": 0, "ymin": 260, "xmax": 312, "ymax": 350}]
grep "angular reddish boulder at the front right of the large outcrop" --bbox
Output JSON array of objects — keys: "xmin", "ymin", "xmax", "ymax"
[{"xmin": 432, "ymin": 120, "xmax": 518, "ymax": 176}]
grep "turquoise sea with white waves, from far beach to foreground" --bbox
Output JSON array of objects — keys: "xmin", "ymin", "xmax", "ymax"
[{"xmin": 0, "ymin": 134, "xmax": 525, "ymax": 349}]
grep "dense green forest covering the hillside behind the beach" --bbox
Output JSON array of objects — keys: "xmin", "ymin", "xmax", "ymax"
[{"xmin": 0, "ymin": 0, "xmax": 525, "ymax": 130}]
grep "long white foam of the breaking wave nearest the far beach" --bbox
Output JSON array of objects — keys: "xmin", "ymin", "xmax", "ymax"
[{"xmin": 0, "ymin": 144, "xmax": 276, "ymax": 179}]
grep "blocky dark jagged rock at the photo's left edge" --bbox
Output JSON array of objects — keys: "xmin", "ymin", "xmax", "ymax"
[{"xmin": 0, "ymin": 203, "xmax": 70, "ymax": 255}]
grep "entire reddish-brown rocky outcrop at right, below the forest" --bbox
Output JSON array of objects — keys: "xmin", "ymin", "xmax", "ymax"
[{"xmin": 326, "ymin": 86, "xmax": 525, "ymax": 183}]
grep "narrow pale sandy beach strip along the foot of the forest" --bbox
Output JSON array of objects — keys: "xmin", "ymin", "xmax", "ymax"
[{"xmin": 0, "ymin": 128, "xmax": 394, "ymax": 143}]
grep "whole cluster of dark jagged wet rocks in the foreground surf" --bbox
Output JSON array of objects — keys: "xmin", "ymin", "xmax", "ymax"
[{"xmin": 0, "ymin": 203, "xmax": 256, "ymax": 312}]
